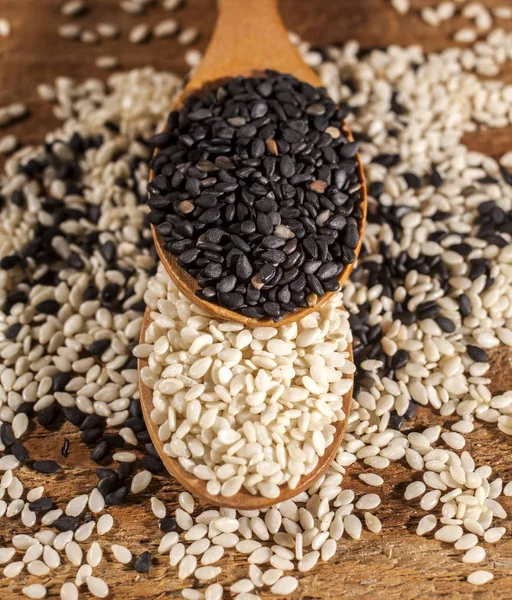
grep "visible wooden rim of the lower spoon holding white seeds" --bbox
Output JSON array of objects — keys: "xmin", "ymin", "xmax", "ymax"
[{"xmin": 138, "ymin": 308, "xmax": 354, "ymax": 510}]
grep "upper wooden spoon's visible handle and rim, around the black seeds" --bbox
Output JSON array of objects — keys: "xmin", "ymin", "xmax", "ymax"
[{"xmin": 150, "ymin": 0, "xmax": 367, "ymax": 327}]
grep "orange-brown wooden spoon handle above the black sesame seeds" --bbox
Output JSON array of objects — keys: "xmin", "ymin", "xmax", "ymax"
[{"xmin": 184, "ymin": 0, "xmax": 320, "ymax": 95}]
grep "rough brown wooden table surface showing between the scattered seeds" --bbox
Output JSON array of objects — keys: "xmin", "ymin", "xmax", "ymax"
[{"xmin": 0, "ymin": 0, "xmax": 512, "ymax": 600}]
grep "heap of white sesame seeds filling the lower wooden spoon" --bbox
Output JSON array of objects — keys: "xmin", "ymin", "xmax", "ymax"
[{"xmin": 138, "ymin": 265, "xmax": 355, "ymax": 498}]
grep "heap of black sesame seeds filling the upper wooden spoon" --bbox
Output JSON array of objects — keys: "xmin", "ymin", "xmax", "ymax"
[{"xmin": 148, "ymin": 71, "xmax": 362, "ymax": 321}]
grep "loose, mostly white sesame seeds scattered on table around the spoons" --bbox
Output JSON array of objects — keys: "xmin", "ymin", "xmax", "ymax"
[{"xmin": 0, "ymin": 10, "xmax": 512, "ymax": 600}]
